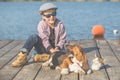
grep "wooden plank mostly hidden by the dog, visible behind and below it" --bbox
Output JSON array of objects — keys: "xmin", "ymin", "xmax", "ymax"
[{"xmin": 61, "ymin": 40, "xmax": 79, "ymax": 80}]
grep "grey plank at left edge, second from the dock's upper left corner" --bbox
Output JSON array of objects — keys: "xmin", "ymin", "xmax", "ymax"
[{"xmin": 0, "ymin": 40, "xmax": 21, "ymax": 57}]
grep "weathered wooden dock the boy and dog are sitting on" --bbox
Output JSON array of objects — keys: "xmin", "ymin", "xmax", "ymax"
[{"xmin": 0, "ymin": 39, "xmax": 120, "ymax": 80}]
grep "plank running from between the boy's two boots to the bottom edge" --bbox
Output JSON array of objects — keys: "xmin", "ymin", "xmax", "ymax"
[{"xmin": 13, "ymin": 58, "xmax": 41, "ymax": 80}]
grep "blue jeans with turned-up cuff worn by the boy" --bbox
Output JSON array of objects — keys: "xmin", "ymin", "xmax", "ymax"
[{"xmin": 20, "ymin": 34, "xmax": 48, "ymax": 54}]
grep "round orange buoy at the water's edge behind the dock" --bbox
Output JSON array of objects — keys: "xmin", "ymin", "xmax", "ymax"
[{"xmin": 92, "ymin": 25, "xmax": 105, "ymax": 35}]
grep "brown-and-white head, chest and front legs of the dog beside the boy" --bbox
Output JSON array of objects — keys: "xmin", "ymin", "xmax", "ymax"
[{"xmin": 56, "ymin": 45, "xmax": 91, "ymax": 74}]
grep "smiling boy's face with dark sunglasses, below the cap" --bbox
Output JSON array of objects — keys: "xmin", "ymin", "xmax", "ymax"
[{"xmin": 42, "ymin": 9, "xmax": 56, "ymax": 24}]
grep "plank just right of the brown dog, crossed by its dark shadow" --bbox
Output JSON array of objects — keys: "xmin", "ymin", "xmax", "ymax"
[{"xmin": 79, "ymin": 40, "xmax": 108, "ymax": 80}]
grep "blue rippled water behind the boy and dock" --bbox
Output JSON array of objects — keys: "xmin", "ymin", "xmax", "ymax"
[{"xmin": 0, "ymin": 2, "xmax": 120, "ymax": 40}]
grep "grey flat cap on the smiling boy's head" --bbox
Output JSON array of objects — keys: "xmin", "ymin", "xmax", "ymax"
[{"xmin": 39, "ymin": 3, "xmax": 57, "ymax": 13}]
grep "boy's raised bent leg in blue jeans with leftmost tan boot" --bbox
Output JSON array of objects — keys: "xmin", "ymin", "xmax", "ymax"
[{"xmin": 12, "ymin": 35, "xmax": 44, "ymax": 67}]
